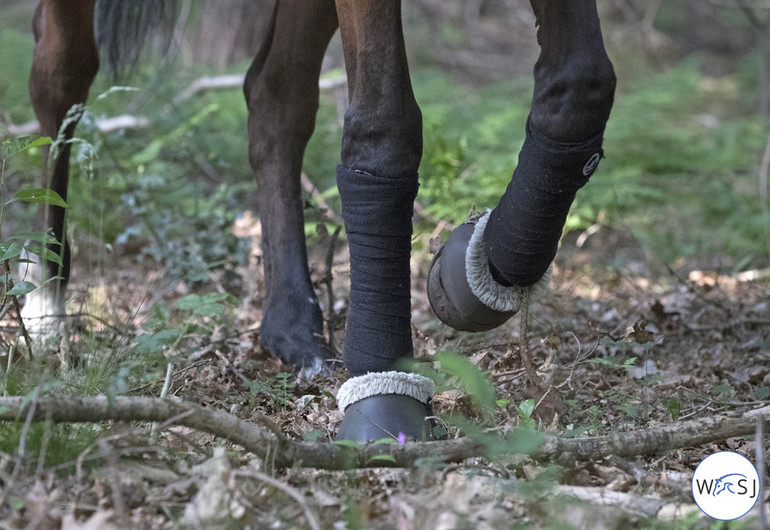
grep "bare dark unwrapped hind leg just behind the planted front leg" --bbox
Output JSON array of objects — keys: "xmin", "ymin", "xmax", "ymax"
[{"xmin": 244, "ymin": 0, "xmax": 337, "ymax": 374}]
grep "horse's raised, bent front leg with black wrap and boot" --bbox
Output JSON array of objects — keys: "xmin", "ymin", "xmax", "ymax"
[{"xmin": 428, "ymin": 0, "xmax": 615, "ymax": 331}]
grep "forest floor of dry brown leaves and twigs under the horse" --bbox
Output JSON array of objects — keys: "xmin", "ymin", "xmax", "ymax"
[{"xmin": 0, "ymin": 211, "xmax": 770, "ymax": 529}]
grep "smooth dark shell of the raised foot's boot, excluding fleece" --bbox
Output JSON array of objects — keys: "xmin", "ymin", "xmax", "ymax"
[{"xmin": 428, "ymin": 221, "xmax": 516, "ymax": 331}]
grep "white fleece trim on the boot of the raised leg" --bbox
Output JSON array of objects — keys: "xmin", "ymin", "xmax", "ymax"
[{"xmin": 465, "ymin": 210, "xmax": 553, "ymax": 312}]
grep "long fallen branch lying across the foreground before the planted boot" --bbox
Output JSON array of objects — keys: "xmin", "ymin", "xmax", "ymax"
[{"xmin": 0, "ymin": 396, "xmax": 770, "ymax": 470}]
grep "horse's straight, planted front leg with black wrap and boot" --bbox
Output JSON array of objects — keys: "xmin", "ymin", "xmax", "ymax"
[{"xmin": 337, "ymin": 0, "xmax": 432, "ymax": 442}]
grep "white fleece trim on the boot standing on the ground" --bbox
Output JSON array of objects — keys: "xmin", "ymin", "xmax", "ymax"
[{"xmin": 337, "ymin": 372, "xmax": 436, "ymax": 413}]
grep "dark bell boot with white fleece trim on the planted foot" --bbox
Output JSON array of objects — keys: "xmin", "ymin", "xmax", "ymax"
[{"xmin": 337, "ymin": 371, "xmax": 435, "ymax": 443}]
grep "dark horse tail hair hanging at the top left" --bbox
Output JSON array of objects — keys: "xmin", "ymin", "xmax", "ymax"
[{"xmin": 96, "ymin": 0, "xmax": 178, "ymax": 77}]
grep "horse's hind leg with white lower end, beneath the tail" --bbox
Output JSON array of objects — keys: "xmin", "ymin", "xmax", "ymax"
[{"xmin": 22, "ymin": 0, "xmax": 99, "ymax": 331}]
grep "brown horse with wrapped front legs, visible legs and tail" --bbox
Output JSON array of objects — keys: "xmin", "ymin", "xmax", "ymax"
[{"xmin": 24, "ymin": 0, "xmax": 616, "ymax": 442}]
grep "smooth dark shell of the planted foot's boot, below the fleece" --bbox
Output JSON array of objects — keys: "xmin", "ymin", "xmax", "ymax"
[{"xmin": 337, "ymin": 394, "xmax": 433, "ymax": 443}]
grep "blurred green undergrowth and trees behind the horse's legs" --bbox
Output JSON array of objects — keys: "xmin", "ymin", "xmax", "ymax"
[{"xmin": 0, "ymin": 0, "xmax": 770, "ymax": 276}]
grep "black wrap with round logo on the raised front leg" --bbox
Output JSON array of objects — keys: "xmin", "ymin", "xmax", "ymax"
[{"xmin": 484, "ymin": 118, "xmax": 603, "ymax": 287}]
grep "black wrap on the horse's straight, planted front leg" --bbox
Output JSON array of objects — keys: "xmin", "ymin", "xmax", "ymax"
[{"xmin": 337, "ymin": 166, "xmax": 418, "ymax": 376}]
